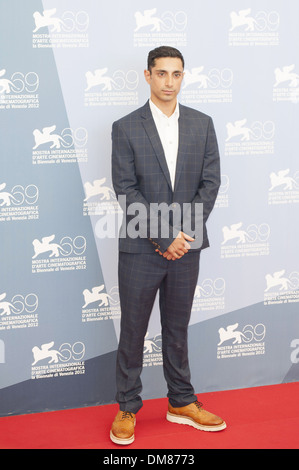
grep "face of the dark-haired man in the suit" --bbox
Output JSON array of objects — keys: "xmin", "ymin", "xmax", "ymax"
[{"xmin": 144, "ymin": 57, "xmax": 184, "ymax": 105}]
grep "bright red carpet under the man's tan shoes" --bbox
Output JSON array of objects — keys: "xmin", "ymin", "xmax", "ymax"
[{"xmin": 0, "ymin": 382, "xmax": 299, "ymax": 450}]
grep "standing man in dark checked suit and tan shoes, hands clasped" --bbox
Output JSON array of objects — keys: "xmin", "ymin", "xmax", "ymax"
[{"xmin": 110, "ymin": 46, "xmax": 226, "ymax": 445}]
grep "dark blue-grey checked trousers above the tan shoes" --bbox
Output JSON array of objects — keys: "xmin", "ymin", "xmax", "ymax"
[{"xmin": 116, "ymin": 250, "xmax": 200, "ymax": 413}]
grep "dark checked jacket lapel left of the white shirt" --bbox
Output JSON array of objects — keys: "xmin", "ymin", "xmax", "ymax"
[{"xmin": 141, "ymin": 102, "xmax": 172, "ymax": 190}]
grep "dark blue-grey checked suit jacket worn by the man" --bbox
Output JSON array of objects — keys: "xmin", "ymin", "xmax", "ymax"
[{"xmin": 112, "ymin": 102, "xmax": 220, "ymax": 253}]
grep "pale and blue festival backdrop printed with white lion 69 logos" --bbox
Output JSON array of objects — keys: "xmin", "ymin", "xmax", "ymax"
[{"xmin": 0, "ymin": 0, "xmax": 299, "ymax": 416}]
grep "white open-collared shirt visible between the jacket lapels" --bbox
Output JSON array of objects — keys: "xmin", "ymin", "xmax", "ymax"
[{"xmin": 149, "ymin": 100, "xmax": 180, "ymax": 189}]
